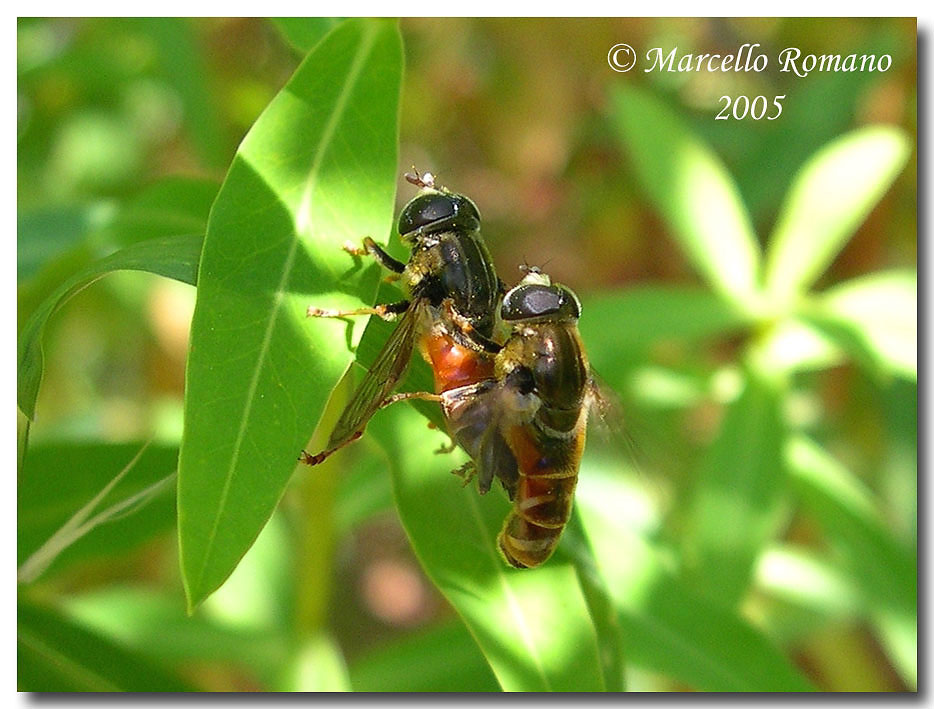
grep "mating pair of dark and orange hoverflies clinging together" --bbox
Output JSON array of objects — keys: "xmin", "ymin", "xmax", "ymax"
[{"xmin": 301, "ymin": 172, "xmax": 598, "ymax": 568}]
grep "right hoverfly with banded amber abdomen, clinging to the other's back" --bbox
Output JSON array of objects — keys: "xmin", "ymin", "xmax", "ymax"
[{"xmin": 440, "ymin": 267, "xmax": 600, "ymax": 568}]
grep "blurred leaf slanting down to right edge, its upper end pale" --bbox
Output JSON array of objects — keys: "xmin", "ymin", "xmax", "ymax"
[{"xmin": 785, "ymin": 436, "xmax": 918, "ymax": 652}]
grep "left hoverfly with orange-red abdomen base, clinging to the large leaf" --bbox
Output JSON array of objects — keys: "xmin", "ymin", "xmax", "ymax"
[{"xmin": 300, "ymin": 172, "xmax": 505, "ymax": 465}]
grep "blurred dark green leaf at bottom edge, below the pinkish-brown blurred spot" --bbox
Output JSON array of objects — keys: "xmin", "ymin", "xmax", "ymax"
[{"xmin": 350, "ymin": 620, "xmax": 499, "ymax": 692}]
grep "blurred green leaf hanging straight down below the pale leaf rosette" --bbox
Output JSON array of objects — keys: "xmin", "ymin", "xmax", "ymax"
[{"xmin": 683, "ymin": 366, "xmax": 784, "ymax": 607}]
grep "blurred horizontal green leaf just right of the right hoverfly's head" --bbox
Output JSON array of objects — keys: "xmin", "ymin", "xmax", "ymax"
[{"xmin": 580, "ymin": 286, "xmax": 752, "ymax": 361}]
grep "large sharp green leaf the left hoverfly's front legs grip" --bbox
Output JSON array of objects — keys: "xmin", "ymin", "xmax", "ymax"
[{"xmin": 178, "ymin": 20, "xmax": 402, "ymax": 608}]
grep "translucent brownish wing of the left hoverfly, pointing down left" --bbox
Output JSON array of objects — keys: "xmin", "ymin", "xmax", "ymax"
[{"xmin": 327, "ymin": 301, "xmax": 424, "ymax": 450}]
